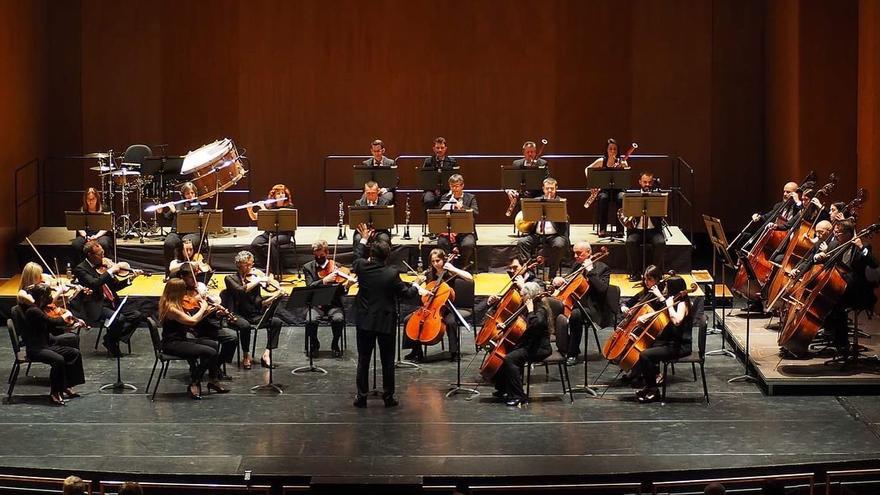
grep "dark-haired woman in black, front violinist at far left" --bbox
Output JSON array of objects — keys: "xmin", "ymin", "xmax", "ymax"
[{"xmin": 20, "ymin": 283, "xmax": 85, "ymax": 406}]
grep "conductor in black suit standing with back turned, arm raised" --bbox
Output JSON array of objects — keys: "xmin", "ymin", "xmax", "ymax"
[{"xmin": 352, "ymin": 224, "xmax": 427, "ymax": 407}]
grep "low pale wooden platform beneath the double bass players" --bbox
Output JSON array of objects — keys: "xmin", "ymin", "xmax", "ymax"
[{"xmin": 716, "ymin": 308, "xmax": 880, "ymax": 395}]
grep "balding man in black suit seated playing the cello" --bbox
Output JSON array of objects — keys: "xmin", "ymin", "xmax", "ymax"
[{"xmin": 553, "ymin": 241, "xmax": 612, "ymax": 366}]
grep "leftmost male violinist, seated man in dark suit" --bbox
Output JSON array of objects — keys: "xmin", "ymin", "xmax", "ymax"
[{"xmin": 73, "ymin": 241, "xmax": 144, "ymax": 357}]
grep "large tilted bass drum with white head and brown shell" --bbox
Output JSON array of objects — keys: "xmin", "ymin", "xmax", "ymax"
[{"xmin": 180, "ymin": 138, "xmax": 247, "ymax": 199}]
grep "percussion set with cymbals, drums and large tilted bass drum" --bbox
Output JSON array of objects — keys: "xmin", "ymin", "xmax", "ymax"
[{"xmin": 84, "ymin": 138, "xmax": 248, "ymax": 242}]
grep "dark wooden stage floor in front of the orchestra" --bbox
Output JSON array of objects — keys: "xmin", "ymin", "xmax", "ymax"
[{"xmin": 0, "ymin": 327, "xmax": 880, "ymax": 484}]
